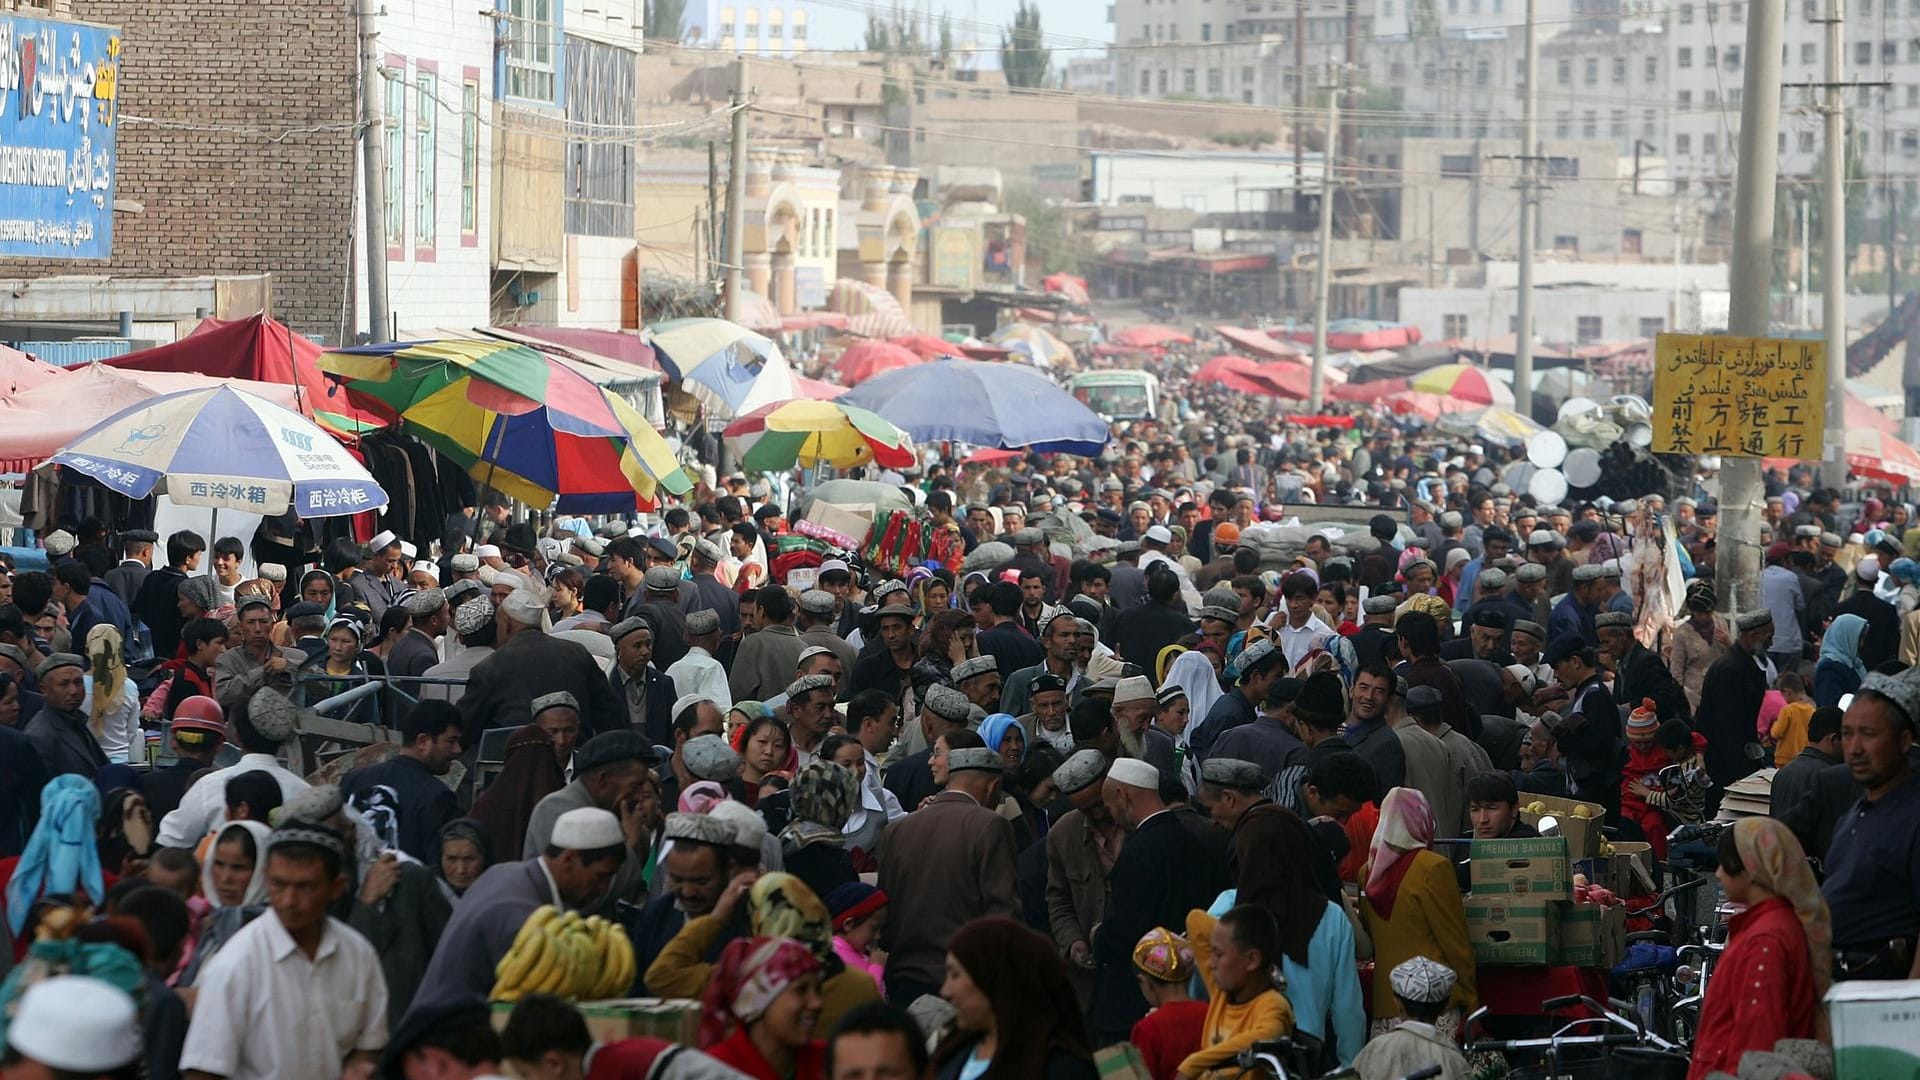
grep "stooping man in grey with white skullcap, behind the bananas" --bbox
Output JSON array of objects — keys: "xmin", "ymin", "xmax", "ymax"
[{"xmin": 410, "ymin": 807, "xmax": 628, "ymax": 1006}]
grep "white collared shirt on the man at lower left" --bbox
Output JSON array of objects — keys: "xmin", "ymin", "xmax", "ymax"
[{"xmin": 180, "ymin": 911, "xmax": 386, "ymax": 1080}]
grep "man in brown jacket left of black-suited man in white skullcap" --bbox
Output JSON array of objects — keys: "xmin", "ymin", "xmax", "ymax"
[{"xmin": 1046, "ymin": 749, "xmax": 1127, "ymax": 1013}]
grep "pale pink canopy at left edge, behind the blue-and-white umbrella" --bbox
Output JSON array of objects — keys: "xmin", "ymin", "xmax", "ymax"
[{"xmin": 0, "ymin": 363, "xmax": 294, "ymax": 473}]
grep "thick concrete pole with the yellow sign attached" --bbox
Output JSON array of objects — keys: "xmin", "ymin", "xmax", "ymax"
[{"xmin": 1715, "ymin": 4, "xmax": 1789, "ymax": 613}]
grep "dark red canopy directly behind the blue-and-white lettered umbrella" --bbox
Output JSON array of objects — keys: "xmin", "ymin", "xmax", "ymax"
[{"xmin": 100, "ymin": 313, "xmax": 380, "ymax": 438}]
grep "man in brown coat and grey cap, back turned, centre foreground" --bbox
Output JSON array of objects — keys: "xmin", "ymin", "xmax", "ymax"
[{"xmin": 879, "ymin": 748, "xmax": 1020, "ymax": 1005}]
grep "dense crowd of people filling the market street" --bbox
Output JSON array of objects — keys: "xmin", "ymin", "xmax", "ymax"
[{"xmin": 0, "ymin": 371, "xmax": 1920, "ymax": 1080}]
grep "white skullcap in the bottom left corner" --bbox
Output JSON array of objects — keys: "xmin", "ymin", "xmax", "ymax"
[{"xmin": 6, "ymin": 974, "xmax": 140, "ymax": 1080}]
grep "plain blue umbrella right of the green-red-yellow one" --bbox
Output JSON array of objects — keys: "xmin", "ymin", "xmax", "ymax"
[{"xmin": 835, "ymin": 359, "xmax": 1112, "ymax": 457}]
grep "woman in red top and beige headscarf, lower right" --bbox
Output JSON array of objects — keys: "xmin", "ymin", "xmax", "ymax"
[{"xmin": 1688, "ymin": 817, "xmax": 1834, "ymax": 1080}]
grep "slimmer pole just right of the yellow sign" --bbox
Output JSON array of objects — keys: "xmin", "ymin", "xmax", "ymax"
[{"xmin": 1820, "ymin": 0, "xmax": 1850, "ymax": 488}]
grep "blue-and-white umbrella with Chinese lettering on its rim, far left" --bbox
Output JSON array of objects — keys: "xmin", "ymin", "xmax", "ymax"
[{"xmin": 48, "ymin": 386, "xmax": 386, "ymax": 517}]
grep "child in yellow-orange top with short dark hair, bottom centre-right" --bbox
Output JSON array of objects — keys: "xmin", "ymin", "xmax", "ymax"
[{"xmin": 1179, "ymin": 903, "xmax": 1294, "ymax": 1080}]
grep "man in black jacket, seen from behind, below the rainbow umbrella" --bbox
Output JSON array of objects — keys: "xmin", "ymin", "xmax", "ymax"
[{"xmin": 459, "ymin": 572, "xmax": 622, "ymax": 736}]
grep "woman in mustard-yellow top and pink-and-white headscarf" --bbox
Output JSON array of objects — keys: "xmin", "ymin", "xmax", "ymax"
[{"xmin": 1359, "ymin": 788, "xmax": 1478, "ymax": 1040}]
